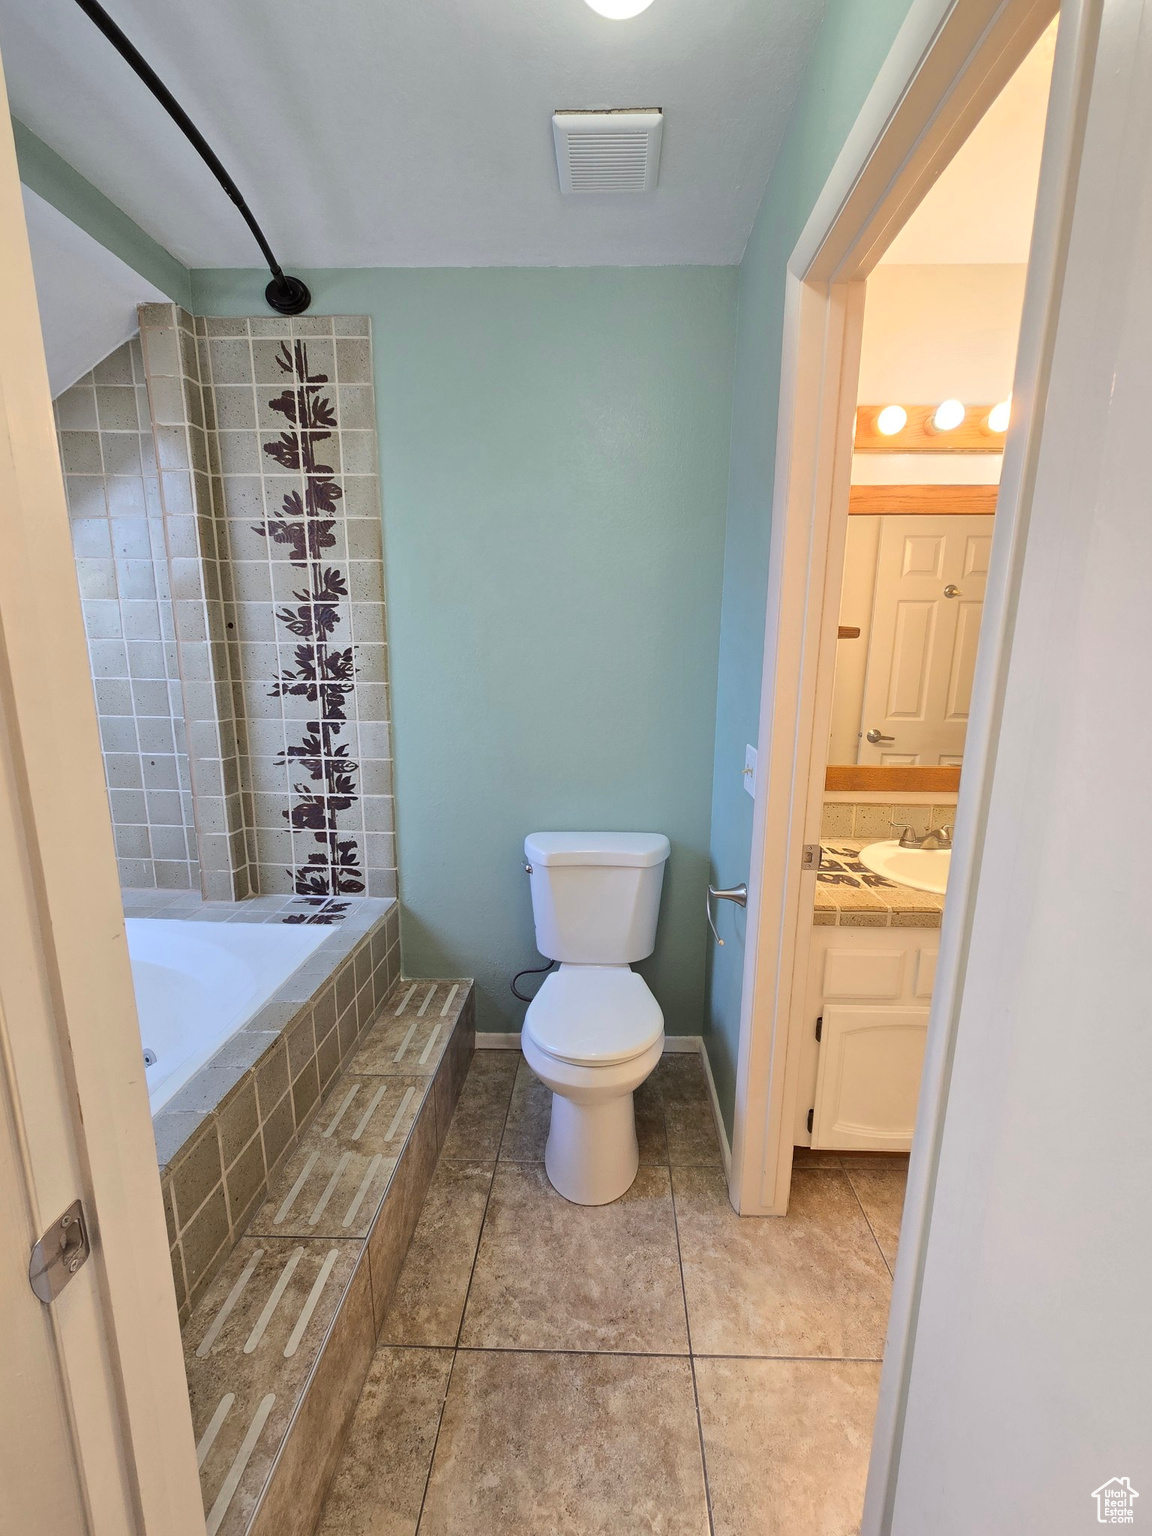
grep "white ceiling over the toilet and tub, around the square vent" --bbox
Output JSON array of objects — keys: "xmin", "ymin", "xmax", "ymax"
[{"xmin": 0, "ymin": 0, "xmax": 825, "ymax": 267}]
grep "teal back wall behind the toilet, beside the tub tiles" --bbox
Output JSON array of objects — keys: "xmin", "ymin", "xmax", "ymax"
[{"xmin": 192, "ymin": 267, "xmax": 734, "ymax": 1034}]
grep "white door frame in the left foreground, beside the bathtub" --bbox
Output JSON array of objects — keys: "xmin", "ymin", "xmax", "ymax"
[{"xmin": 0, "ymin": 48, "xmax": 204, "ymax": 1536}]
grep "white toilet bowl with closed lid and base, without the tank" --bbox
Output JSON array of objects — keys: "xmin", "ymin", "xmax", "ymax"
[{"xmin": 521, "ymin": 966, "xmax": 664, "ymax": 1206}]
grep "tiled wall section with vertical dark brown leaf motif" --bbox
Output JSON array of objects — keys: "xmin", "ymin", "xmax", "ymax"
[{"xmin": 195, "ymin": 315, "xmax": 396, "ymax": 897}]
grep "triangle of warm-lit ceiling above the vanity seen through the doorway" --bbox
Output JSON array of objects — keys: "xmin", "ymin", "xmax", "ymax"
[{"xmin": 883, "ymin": 22, "xmax": 1055, "ymax": 266}]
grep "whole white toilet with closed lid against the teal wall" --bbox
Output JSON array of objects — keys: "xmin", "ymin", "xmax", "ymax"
[{"xmin": 521, "ymin": 833, "xmax": 670, "ymax": 1206}]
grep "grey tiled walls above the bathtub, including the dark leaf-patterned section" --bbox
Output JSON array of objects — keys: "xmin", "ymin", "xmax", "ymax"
[{"xmin": 67, "ymin": 304, "xmax": 396, "ymax": 900}]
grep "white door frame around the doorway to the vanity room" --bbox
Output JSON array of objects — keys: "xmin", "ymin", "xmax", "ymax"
[{"xmin": 730, "ymin": 0, "xmax": 1075, "ymax": 1215}]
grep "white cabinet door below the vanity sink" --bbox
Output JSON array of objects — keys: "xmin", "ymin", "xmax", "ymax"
[{"xmin": 813, "ymin": 1003, "xmax": 928, "ymax": 1152}]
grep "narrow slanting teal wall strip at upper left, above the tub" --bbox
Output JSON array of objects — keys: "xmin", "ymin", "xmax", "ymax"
[{"xmin": 12, "ymin": 118, "xmax": 192, "ymax": 307}]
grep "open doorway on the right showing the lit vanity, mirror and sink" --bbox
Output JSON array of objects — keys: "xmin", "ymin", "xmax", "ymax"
[{"xmin": 791, "ymin": 22, "xmax": 1057, "ymax": 1161}]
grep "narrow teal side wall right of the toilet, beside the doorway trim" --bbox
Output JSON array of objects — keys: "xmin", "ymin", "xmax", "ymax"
[{"xmin": 705, "ymin": 0, "xmax": 911, "ymax": 1134}]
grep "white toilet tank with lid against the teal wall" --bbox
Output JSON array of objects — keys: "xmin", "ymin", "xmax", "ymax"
[{"xmin": 524, "ymin": 833, "xmax": 670, "ymax": 965}]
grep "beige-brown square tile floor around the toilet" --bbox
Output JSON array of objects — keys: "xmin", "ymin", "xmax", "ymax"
[{"xmin": 316, "ymin": 1051, "xmax": 906, "ymax": 1536}]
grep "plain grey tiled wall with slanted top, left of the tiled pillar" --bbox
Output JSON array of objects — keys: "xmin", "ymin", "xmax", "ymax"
[{"xmin": 55, "ymin": 339, "xmax": 200, "ymax": 889}]
